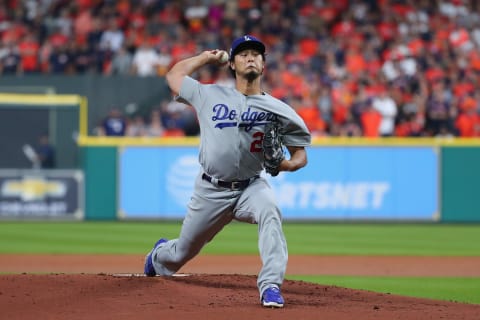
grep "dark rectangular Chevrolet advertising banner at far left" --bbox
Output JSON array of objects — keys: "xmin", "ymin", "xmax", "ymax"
[{"xmin": 0, "ymin": 169, "xmax": 84, "ymax": 219}]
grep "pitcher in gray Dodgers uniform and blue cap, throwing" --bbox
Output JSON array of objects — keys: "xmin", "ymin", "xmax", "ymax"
[{"xmin": 144, "ymin": 35, "xmax": 311, "ymax": 308}]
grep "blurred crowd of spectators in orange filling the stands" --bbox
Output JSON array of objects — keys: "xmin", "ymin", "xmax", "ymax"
[{"xmin": 0, "ymin": 0, "xmax": 480, "ymax": 137}]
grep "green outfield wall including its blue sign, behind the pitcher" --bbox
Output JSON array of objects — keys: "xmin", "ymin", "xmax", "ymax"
[{"xmin": 81, "ymin": 139, "xmax": 480, "ymax": 222}]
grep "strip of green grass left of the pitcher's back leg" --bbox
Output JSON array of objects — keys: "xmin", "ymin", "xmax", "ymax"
[{"xmin": 0, "ymin": 222, "xmax": 180, "ymax": 254}]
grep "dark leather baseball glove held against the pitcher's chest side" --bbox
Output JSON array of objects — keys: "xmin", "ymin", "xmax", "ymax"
[{"xmin": 262, "ymin": 121, "xmax": 285, "ymax": 177}]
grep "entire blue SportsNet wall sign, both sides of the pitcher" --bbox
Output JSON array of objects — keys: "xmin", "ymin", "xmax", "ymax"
[{"xmin": 119, "ymin": 147, "xmax": 439, "ymax": 220}]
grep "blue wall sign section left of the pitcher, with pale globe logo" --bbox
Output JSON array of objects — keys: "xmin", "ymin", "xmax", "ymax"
[{"xmin": 119, "ymin": 147, "xmax": 200, "ymax": 218}]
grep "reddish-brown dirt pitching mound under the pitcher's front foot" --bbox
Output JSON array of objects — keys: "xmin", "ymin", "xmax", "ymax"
[{"xmin": 0, "ymin": 274, "xmax": 480, "ymax": 320}]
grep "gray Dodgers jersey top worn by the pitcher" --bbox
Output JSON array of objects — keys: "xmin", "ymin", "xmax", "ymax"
[{"xmin": 177, "ymin": 77, "xmax": 310, "ymax": 181}]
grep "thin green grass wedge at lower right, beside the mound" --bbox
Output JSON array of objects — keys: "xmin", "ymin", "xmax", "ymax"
[{"xmin": 288, "ymin": 276, "xmax": 480, "ymax": 304}]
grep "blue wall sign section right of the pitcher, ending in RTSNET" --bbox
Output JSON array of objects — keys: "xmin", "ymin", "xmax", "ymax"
[{"xmin": 270, "ymin": 147, "xmax": 438, "ymax": 220}]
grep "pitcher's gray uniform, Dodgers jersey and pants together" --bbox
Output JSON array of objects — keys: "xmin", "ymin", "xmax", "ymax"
[{"xmin": 152, "ymin": 77, "xmax": 310, "ymax": 297}]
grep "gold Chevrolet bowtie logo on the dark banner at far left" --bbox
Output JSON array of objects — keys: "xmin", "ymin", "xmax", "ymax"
[{"xmin": 1, "ymin": 177, "xmax": 67, "ymax": 201}]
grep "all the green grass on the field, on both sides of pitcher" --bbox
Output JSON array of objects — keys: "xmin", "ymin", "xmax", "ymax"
[{"xmin": 0, "ymin": 221, "xmax": 480, "ymax": 304}]
